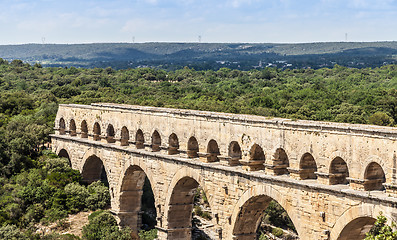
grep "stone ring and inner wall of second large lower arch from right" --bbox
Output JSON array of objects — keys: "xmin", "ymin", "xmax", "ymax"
[{"xmin": 229, "ymin": 185, "xmax": 298, "ymax": 239}]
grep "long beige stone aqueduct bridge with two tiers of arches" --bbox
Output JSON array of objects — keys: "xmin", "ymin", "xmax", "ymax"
[{"xmin": 52, "ymin": 104, "xmax": 397, "ymax": 240}]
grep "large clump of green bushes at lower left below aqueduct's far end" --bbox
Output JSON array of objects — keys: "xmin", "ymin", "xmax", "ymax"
[{"xmin": 0, "ymin": 152, "xmax": 110, "ymax": 234}]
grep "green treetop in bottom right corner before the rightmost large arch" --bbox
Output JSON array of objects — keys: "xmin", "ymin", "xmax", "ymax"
[{"xmin": 365, "ymin": 213, "xmax": 397, "ymax": 240}]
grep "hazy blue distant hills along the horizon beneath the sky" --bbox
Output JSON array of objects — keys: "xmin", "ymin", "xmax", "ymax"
[{"xmin": 0, "ymin": 42, "xmax": 397, "ymax": 70}]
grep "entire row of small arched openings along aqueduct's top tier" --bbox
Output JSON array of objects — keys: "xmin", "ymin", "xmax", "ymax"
[{"xmin": 59, "ymin": 118, "xmax": 386, "ymax": 190}]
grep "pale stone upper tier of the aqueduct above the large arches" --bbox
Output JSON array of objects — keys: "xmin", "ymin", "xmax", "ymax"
[{"xmin": 56, "ymin": 104, "xmax": 397, "ymax": 193}]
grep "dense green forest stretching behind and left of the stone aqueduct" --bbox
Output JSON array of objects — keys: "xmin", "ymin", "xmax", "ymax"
[{"xmin": 0, "ymin": 59, "xmax": 397, "ymax": 239}]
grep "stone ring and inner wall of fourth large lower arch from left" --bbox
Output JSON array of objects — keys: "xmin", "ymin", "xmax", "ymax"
[{"xmin": 160, "ymin": 168, "xmax": 213, "ymax": 239}]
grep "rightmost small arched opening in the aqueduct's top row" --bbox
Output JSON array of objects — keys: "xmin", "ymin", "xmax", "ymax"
[{"xmin": 364, "ymin": 162, "xmax": 386, "ymax": 191}]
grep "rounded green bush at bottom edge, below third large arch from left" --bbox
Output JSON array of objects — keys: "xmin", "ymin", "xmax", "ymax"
[{"xmin": 83, "ymin": 211, "xmax": 132, "ymax": 240}]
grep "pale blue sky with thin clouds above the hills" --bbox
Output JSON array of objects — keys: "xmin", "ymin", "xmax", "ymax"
[{"xmin": 0, "ymin": 0, "xmax": 397, "ymax": 45}]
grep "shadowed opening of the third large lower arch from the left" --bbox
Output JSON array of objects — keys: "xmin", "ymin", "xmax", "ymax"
[{"xmin": 118, "ymin": 165, "xmax": 157, "ymax": 232}]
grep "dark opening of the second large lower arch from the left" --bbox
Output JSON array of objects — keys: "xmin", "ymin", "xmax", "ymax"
[{"xmin": 81, "ymin": 154, "xmax": 108, "ymax": 185}]
